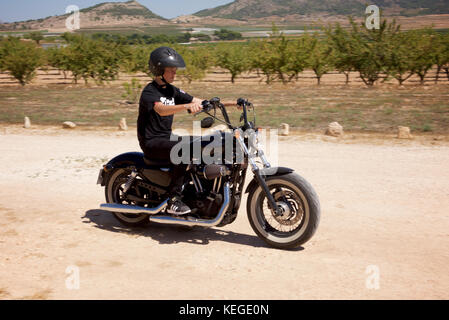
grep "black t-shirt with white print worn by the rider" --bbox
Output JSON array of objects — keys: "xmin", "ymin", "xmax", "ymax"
[{"xmin": 137, "ymin": 81, "xmax": 193, "ymax": 146}]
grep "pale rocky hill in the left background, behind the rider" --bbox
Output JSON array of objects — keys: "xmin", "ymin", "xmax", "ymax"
[{"xmin": 0, "ymin": 1, "xmax": 167, "ymax": 31}]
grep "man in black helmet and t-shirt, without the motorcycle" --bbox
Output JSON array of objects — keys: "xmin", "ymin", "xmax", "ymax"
[{"xmin": 137, "ymin": 47, "xmax": 236, "ymax": 215}]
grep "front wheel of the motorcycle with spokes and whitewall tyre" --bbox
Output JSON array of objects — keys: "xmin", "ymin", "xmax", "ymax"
[{"xmin": 247, "ymin": 173, "xmax": 320, "ymax": 249}]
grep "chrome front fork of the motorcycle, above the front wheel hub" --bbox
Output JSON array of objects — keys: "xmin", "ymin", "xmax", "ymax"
[{"xmin": 234, "ymin": 129, "xmax": 282, "ymax": 216}]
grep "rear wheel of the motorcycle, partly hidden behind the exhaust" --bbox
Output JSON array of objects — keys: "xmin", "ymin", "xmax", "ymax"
[{"xmin": 105, "ymin": 169, "xmax": 150, "ymax": 227}]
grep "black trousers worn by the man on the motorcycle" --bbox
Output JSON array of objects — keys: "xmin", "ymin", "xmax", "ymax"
[{"xmin": 141, "ymin": 136, "xmax": 194, "ymax": 198}]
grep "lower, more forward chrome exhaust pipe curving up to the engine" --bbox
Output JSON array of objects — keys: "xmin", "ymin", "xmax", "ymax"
[{"xmin": 150, "ymin": 183, "xmax": 230, "ymax": 227}]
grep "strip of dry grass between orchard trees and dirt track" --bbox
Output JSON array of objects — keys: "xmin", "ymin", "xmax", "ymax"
[{"xmin": 0, "ymin": 83, "xmax": 449, "ymax": 134}]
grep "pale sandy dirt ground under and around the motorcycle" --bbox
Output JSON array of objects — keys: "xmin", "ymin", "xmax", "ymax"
[{"xmin": 0, "ymin": 126, "xmax": 449, "ymax": 299}]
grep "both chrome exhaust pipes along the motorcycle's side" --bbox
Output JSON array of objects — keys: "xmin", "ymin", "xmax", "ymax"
[{"xmin": 100, "ymin": 182, "xmax": 230, "ymax": 227}]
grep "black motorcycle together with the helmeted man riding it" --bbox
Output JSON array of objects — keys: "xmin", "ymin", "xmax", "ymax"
[{"xmin": 97, "ymin": 47, "xmax": 320, "ymax": 249}]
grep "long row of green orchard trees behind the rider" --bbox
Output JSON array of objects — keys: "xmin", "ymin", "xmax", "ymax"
[{"xmin": 0, "ymin": 21, "xmax": 449, "ymax": 86}]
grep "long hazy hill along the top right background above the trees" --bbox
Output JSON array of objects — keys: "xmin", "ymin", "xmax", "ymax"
[{"xmin": 194, "ymin": 0, "xmax": 449, "ymax": 19}]
